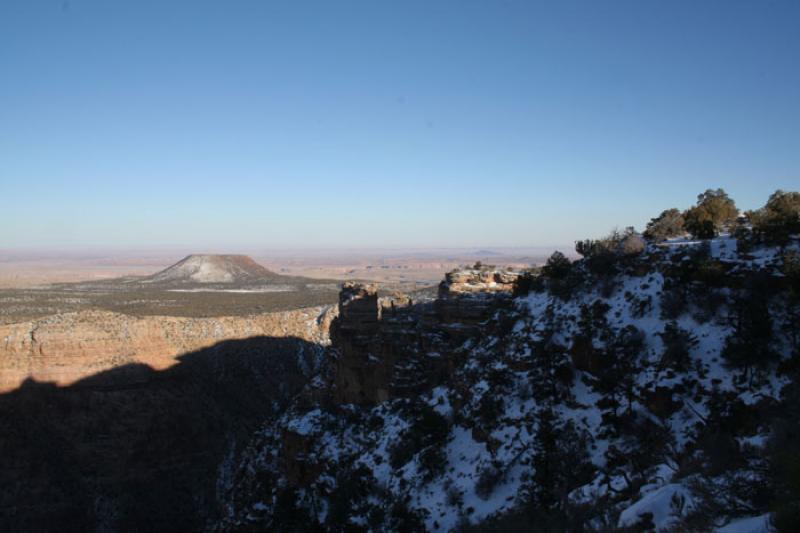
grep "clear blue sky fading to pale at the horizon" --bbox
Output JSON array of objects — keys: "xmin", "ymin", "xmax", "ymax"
[{"xmin": 0, "ymin": 0, "xmax": 800, "ymax": 249}]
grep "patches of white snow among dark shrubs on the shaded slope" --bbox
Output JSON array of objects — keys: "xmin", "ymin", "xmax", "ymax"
[{"xmin": 228, "ymin": 236, "xmax": 796, "ymax": 533}]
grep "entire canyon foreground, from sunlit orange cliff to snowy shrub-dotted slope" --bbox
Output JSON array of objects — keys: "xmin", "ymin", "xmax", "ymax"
[{"xmin": 0, "ymin": 227, "xmax": 800, "ymax": 532}]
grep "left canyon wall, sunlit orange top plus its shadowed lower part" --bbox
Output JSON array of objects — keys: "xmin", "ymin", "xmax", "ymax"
[{"xmin": 0, "ymin": 307, "xmax": 336, "ymax": 532}]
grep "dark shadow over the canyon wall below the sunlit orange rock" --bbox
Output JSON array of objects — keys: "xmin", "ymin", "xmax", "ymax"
[{"xmin": 0, "ymin": 337, "xmax": 323, "ymax": 532}]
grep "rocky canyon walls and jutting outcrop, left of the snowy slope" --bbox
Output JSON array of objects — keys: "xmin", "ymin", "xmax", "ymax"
[{"xmin": 0, "ymin": 264, "xmax": 514, "ymax": 531}]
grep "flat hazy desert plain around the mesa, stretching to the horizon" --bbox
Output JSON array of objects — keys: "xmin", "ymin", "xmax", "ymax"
[{"xmin": 0, "ymin": 249, "xmax": 544, "ymax": 324}]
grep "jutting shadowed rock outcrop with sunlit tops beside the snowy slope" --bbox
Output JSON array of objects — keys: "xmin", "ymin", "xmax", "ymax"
[{"xmin": 331, "ymin": 270, "xmax": 518, "ymax": 405}]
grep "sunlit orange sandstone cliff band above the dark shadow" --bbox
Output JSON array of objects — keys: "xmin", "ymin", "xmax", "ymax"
[{"xmin": 0, "ymin": 307, "xmax": 337, "ymax": 392}]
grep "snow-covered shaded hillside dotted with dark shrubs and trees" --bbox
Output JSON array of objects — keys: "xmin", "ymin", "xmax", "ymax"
[{"xmin": 219, "ymin": 237, "xmax": 800, "ymax": 531}]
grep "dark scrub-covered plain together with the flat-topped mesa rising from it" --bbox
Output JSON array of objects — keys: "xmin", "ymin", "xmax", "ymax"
[{"xmin": 0, "ymin": 255, "xmax": 338, "ymax": 324}]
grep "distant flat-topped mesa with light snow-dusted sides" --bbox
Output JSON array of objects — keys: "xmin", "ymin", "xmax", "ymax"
[{"xmin": 143, "ymin": 254, "xmax": 281, "ymax": 283}]
